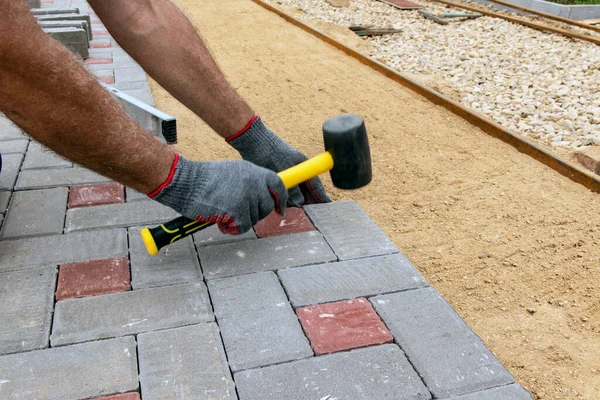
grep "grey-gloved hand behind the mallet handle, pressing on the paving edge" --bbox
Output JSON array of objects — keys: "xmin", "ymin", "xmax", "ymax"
[{"xmin": 227, "ymin": 117, "xmax": 331, "ymax": 207}]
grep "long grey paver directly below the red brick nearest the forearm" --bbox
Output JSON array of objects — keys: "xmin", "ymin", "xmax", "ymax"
[{"xmin": 65, "ymin": 199, "xmax": 179, "ymax": 232}]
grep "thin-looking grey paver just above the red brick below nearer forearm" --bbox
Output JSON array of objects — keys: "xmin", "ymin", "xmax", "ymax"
[{"xmin": 15, "ymin": 167, "xmax": 110, "ymax": 190}]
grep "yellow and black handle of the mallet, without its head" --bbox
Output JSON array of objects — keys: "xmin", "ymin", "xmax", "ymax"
[{"xmin": 141, "ymin": 151, "xmax": 333, "ymax": 256}]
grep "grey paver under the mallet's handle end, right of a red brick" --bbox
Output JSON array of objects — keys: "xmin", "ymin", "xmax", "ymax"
[{"xmin": 129, "ymin": 228, "xmax": 202, "ymax": 289}]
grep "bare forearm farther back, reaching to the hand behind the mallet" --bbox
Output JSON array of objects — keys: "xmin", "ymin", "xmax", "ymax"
[{"xmin": 90, "ymin": 0, "xmax": 254, "ymax": 138}]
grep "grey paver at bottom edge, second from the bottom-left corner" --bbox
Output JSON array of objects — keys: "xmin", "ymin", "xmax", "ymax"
[{"xmin": 138, "ymin": 323, "xmax": 237, "ymax": 399}]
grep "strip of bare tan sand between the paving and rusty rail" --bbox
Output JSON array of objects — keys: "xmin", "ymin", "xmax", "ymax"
[{"xmin": 152, "ymin": 0, "xmax": 600, "ymax": 399}]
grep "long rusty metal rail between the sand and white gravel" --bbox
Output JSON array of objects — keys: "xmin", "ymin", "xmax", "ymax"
[{"xmin": 252, "ymin": 0, "xmax": 600, "ymax": 193}]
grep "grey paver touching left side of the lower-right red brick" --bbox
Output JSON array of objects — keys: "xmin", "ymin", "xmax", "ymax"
[{"xmin": 208, "ymin": 272, "xmax": 313, "ymax": 372}]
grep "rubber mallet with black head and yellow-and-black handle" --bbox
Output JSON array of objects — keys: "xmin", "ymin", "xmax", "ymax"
[{"xmin": 141, "ymin": 114, "xmax": 372, "ymax": 255}]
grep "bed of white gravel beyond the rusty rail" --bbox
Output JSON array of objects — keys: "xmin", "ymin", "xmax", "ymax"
[{"xmin": 269, "ymin": 0, "xmax": 600, "ymax": 150}]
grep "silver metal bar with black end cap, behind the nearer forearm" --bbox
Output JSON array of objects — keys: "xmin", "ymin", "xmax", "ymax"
[{"xmin": 100, "ymin": 82, "xmax": 177, "ymax": 144}]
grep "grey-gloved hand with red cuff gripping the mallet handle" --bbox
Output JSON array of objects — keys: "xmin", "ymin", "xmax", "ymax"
[{"xmin": 148, "ymin": 155, "xmax": 288, "ymax": 235}]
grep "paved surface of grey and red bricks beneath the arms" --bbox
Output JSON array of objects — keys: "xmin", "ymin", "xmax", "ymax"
[{"xmin": 0, "ymin": 0, "xmax": 530, "ymax": 400}]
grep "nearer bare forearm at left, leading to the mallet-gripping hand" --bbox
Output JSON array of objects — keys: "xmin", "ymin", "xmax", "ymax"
[{"xmin": 0, "ymin": 1, "xmax": 174, "ymax": 193}]
